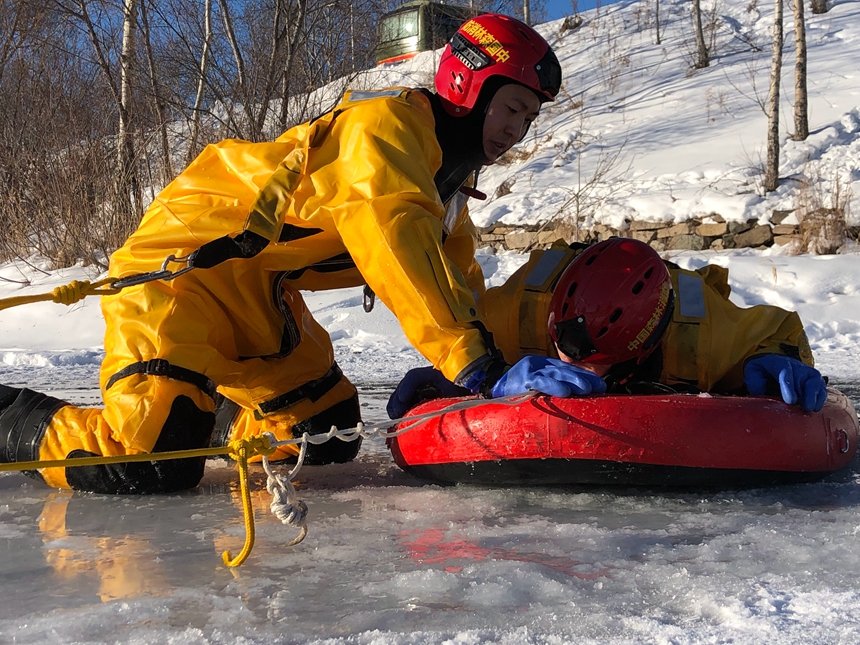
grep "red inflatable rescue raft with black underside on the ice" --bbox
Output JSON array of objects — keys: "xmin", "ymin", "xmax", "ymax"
[{"xmin": 389, "ymin": 389, "xmax": 858, "ymax": 488}]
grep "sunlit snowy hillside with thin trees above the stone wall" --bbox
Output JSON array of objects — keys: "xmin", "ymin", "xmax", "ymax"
[{"xmin": 358, "ymin": 0, "xmax": 860, "ymax": 228}]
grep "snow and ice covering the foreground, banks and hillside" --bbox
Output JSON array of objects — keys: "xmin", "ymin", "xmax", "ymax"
[{"xmin": 0, "ymin": 0, "xmax": 860, "ymax": 645}]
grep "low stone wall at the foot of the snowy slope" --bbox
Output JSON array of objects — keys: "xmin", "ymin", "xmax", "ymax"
[{"xmin": 478, "ymin": 211, "xmax": 860, "ymax": 252}]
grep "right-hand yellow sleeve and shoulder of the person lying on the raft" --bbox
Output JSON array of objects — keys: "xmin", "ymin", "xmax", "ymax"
[{"xmin": 660, "ymin": 265, "xmax": 814, "ymax": 392}]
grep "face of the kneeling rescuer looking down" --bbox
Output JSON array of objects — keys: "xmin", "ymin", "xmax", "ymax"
[{"xmin": 484, "ymin": 83, "xmax": 540, "ymax": 163}]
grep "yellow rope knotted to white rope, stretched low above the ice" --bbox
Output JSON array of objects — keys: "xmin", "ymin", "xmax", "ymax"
[{"xmin": 0, "ymin": 392, "xmax": 537, "ymax": 568}]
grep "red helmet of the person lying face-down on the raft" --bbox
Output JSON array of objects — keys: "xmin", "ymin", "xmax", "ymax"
[{"xmin": 548, "ymin": 237, "xmax": 674, "ymax": 365}]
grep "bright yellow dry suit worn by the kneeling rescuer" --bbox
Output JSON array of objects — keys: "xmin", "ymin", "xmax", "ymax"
[{"xmin": 0, "ymin": 88, "xmax": 488, "ymax": 492}]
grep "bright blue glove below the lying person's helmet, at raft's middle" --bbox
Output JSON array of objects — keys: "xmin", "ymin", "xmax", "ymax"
[{"xmin": 493, "ymin": 356, "xmax": 606, "ymax": 397}]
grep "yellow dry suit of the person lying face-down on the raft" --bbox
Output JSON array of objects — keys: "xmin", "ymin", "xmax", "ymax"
[{"xmin": 483, "ymin": 241, "xmax": 814, "ymax": 393}]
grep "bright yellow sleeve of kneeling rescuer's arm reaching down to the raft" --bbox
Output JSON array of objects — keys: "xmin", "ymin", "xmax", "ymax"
[{"xmin": 308, "ymin": 92, "xmax": 488, "ymax": 380}]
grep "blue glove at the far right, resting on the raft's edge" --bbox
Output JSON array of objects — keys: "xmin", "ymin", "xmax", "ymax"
[{"xmin": 744, "ymin": 354, "xmax": 827, "ymax": 412}]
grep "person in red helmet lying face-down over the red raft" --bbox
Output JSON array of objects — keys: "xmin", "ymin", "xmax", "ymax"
[{"xmin": 389, "ymin": 238, "xmax": 827, "ymax": 416}]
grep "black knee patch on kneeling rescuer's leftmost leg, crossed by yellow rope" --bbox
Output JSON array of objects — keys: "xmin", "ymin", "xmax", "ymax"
[{"xmin": 66, "ymin": 396, "xmax": 215, "ymax": 494}]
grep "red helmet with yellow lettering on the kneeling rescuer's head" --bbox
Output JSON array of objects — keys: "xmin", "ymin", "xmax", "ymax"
[{"xmin": 436, "ymin": 13, "xmax": 561, "ymax": 116}]
